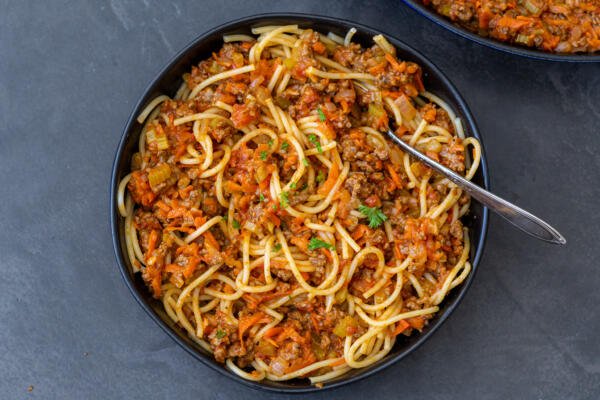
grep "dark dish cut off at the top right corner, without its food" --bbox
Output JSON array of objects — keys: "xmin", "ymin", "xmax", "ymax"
[{"xmin": 403, "ymin": 0, "xmax": 600, "ymax": 62}]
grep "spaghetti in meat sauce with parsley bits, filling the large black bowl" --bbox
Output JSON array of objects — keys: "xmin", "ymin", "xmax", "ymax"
[{"xmin": 117, "ymin": 25, "xmax": 481, "ymax": 385}]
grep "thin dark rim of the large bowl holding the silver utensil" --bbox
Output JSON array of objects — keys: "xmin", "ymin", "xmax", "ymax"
[{"xmin": 109, "ymin": 12, "xmax": 490, "ymax": 394}]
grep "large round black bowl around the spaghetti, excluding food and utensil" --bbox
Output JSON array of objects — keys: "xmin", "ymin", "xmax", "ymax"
[{"xmin": 110, "ymin": 14, "xmax": 488, "ymax": 392}]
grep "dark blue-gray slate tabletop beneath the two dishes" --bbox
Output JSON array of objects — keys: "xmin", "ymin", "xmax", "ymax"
[{"xmin": 0, "ymin": 0, "xmax": 600, "ymax": 399}]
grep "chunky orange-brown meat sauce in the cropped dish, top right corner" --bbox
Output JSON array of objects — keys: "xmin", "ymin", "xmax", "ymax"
[{"xmin": 421, "ymin": 0, "xmax": 600, "ymax": 53}]
